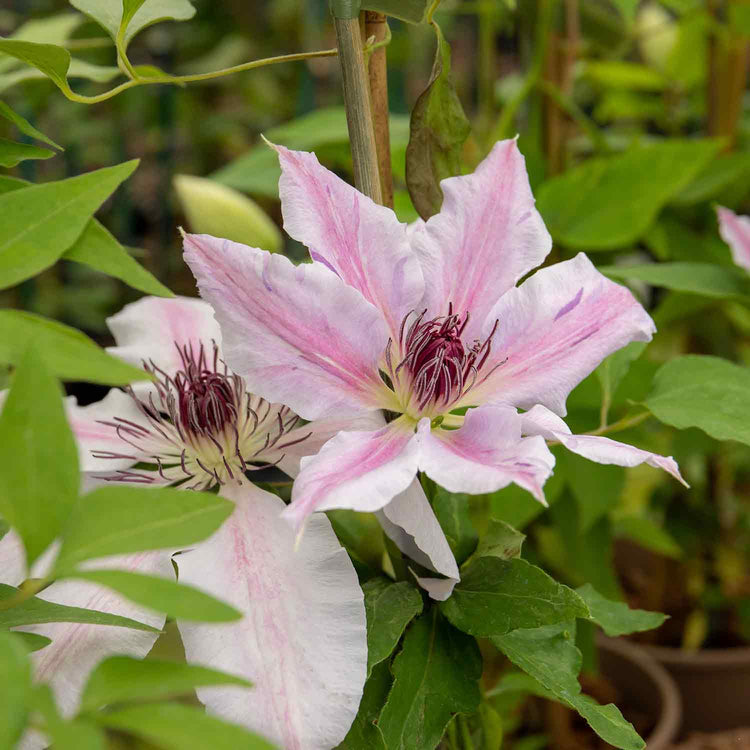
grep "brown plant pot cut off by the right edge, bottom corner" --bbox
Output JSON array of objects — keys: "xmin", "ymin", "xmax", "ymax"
[{"xmin": 641, "ymin": 646, "xmax": 750, "ymax": 733}]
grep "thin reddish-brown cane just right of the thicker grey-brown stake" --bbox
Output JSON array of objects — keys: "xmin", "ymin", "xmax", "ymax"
[{"xmin": 365, "ymin": 10, "xmax": 393, "ymax": 208}]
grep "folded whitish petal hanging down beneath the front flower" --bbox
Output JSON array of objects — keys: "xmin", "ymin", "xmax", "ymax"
[{"xmin": 377, "ymin": 479, "xmax": 461, "ymax": 601}]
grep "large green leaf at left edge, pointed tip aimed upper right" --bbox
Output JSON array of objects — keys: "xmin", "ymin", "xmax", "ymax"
[{"xmin": 0, "ymin": 160, "xmax": 138, "ymax": 289}]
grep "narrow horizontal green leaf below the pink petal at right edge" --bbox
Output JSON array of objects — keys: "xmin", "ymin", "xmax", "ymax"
[{"xmin": 599, "ymin": 263, "xmax": 750, "ymax": 304}]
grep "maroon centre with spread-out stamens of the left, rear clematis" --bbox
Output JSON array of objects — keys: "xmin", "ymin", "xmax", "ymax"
[{"xmin": 93, "ymin": 344, "xmax": 307, "ymax": 489}]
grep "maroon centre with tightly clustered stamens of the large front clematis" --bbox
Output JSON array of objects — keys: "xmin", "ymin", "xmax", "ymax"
[{"xmin": 385, "ymin": 303, "xmax": 498, "ymax": 414}]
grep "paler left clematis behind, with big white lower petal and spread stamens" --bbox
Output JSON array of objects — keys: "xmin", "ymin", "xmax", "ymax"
[{"xmin": 0, "ymin": 297, "xmax": 367, "ymax": 750}]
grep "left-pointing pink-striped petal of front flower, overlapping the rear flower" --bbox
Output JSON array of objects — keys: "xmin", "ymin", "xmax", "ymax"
[{"xmin": 185, "ymin": 234, "xmax": 388, "ymax": 419}]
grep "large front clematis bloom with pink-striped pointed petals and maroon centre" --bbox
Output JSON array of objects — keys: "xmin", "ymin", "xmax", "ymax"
[{"xmin": 185, "ymin": 140, "xmax": 680, "ymax": 598}]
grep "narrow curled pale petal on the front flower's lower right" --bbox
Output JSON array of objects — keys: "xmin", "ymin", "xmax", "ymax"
[{"xmin": 521, "ymin": 405, "xmax": 688, "ymax": 487}]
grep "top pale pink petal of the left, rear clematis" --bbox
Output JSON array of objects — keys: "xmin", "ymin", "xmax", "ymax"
[{"xmin": 107, "ymin": 297, "xmax": 221, "ymax": 375}]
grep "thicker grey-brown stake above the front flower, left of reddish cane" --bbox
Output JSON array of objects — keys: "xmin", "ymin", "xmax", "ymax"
[{"xmin": 334, "ymin": 18, "xmax": 383, "ymax": 203}]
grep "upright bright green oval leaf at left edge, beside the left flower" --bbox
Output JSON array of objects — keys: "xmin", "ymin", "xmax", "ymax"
[{"xmin": 0, "ymin": 350, "xmax": 80, "ymax": 566}]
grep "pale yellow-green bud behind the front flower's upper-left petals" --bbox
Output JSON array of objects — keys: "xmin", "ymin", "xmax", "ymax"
[{"xmin": 174, "ymin": 175, "xmax": 282, "ymax": 253}]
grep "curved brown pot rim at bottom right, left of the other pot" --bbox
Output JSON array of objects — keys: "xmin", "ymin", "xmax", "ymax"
[{"xmin": 598, "ymin": 636, "xmax": 682, "ymax": 750}]
